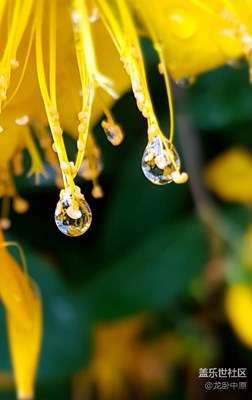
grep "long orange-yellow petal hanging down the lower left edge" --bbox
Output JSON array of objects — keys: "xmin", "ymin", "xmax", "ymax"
[{"xmin": 0, "ymin": 230, "xmax": 42, "ymax": 400}]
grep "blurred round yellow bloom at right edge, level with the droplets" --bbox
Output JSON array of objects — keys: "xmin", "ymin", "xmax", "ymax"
[{"xmin": 205, "ymin": 147, "xmax": 252, "ymax": 206}]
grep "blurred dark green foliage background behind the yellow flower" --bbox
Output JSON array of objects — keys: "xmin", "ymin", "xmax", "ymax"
[{"xmin": 0, "ymin": 42, "xmax": 252, "ymax": 400}]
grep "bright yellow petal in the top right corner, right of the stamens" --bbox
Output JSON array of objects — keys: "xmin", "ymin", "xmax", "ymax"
[{"xmin": 130, "ymin": 0, "xmax": 252, "ymax": 80}]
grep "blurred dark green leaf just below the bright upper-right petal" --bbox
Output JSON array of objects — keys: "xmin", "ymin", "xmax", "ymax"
[{"xmin": 185, "ymin": 66, "xmax": 252, "ymax": 131}]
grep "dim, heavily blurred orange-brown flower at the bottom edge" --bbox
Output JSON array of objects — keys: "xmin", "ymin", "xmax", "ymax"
[{"xmin": 73, "ymin": 316, "xmax": 182, "ymax": 400}]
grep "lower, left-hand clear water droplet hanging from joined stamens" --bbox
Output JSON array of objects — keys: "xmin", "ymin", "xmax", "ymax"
[{"xmin": 55, "ymin": 189, "xmax": 92, "ymax": 237}]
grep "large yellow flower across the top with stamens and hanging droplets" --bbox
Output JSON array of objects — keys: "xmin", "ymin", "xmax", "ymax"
[{"xmin": 0, "ymin": 0, "xmax": 251, "ymax": 236}]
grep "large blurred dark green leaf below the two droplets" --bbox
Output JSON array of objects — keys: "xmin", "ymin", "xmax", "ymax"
[{"xmin": 79, "ymin": 212, "xmax": 206, "ymax": 320}]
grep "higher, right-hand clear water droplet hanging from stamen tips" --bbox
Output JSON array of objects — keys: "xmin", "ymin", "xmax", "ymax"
[{"xmin": 142, "ymin": 136, "xmax": 180, "ymax": 185}]
